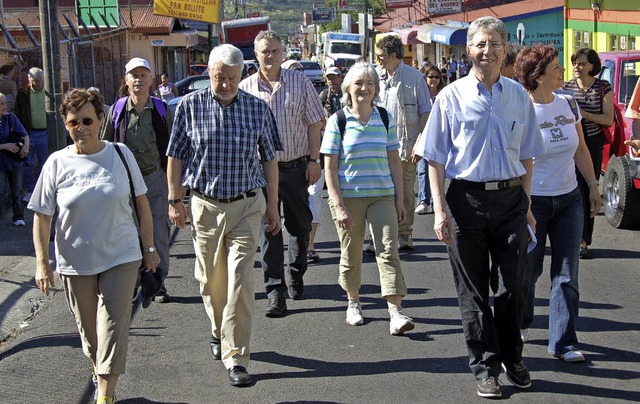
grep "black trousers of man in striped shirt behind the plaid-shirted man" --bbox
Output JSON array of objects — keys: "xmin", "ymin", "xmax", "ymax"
[{"xmin": 260, "ymin": 164, "xmax": 313, "ymax": 298}]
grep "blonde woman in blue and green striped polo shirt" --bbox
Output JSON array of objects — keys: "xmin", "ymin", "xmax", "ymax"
[{"xmin": 320, "ymin": 63, "xmax": 414, "ymax": 335}]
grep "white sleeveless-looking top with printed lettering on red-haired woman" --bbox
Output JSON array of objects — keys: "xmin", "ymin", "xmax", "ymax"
[{"xmin": 531, "ymin": 94, "xmax": 582, "ymax": 196}]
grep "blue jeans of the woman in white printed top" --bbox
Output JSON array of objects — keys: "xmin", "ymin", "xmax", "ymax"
[{"xmin": 522, "ymin": 187, "xmax": 584, "ymax": 355}]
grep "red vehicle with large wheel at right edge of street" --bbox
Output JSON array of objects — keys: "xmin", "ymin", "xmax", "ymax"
[{"xmin": 599, "ymin": 50, "xmax": 640, "ymax": 229}]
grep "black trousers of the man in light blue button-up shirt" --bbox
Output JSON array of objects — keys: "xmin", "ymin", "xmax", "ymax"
[{"xmin": 446, "ymin": 180, "xmax": 529, "ymax": 380}]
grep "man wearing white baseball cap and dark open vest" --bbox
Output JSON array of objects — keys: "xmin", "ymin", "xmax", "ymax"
[{"xmin": 101, "ymin": 57, "xmax": 173, "ymax": 303}]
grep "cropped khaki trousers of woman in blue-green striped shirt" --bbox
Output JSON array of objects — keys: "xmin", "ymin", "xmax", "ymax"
[{"xmin": 329, "ymin": 196, "xmax": 407, "ymax": 297}]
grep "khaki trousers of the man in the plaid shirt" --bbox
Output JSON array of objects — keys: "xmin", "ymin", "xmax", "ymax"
[{"xmin": 189, "ymin": 190, "xmax": 266, "ymax": 369}]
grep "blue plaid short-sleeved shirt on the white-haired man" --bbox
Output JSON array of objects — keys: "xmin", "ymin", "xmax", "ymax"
[{"xmin": 167, "ymin": 87, "xmax": 282, "ymax": 198}]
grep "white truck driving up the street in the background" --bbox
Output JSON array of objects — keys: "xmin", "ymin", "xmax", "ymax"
[{"xmin": 320, "ymin": 32, "xmax": 364, "ymax": 70}]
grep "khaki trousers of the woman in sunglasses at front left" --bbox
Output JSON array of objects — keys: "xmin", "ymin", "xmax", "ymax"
[{"xmin": 60, "ymin": 261, "xmax": 140, "ymax": 375}]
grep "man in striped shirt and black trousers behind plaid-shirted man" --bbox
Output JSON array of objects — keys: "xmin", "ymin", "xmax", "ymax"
[{"xmin": 240, "ymin": 31, "xmax": 324, "ymax": 317}]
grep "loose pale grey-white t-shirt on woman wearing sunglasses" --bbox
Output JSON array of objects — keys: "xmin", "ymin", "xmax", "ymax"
[{"xmin": 27, "ymin": 142, "xmax": 147, "ymax": 275}]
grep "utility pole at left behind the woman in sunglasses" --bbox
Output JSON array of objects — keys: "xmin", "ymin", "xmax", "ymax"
[{"xmin": 40, "ymin": 0, "xmax": 67, "ymax": 153}]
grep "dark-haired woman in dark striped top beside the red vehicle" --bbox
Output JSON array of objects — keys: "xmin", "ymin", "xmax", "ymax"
[{"xmin": 564, "ymin": 48, "xmax": 613, "ymax": 258}]
